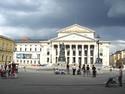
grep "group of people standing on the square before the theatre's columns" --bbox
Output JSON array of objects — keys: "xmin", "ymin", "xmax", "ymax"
[{"xmin": 67, "ymin": 64, "xmax": 97, "ymax": 77}]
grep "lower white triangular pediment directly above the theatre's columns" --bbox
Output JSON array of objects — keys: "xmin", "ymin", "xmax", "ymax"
[{"xmin": 51, "ymin": 33, "xmax": 95, "ymax": 41}]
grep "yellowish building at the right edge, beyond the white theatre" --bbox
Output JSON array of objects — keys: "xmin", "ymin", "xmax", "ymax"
[{"xmin": 110, "ymin": 50, "xmax": 125, "ymax": 67}]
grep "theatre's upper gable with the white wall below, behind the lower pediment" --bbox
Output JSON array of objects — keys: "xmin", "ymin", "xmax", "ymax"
[{"xmin": 58, "ymin": 24, "xmax": 95, "ymax": 38}]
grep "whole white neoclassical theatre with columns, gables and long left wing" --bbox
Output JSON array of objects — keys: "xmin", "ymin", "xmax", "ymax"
[{"xmin": 14, "ymin": 24, "xmax": 109, "ymax": 66}]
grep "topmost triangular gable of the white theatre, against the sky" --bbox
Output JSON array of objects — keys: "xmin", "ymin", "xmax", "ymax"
[{"xmin": 57, "ymin": 24, "xmax": 95, "ymax": 33}]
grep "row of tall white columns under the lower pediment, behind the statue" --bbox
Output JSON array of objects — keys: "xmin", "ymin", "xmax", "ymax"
[{"xmin": 52, "ymin": 42, "xmax": 100, "ymax": 67}]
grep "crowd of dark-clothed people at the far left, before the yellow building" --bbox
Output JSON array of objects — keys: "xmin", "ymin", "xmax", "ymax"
[{"xmin": 0, "ymin": 63, "xmax": 18, "ymax": 78}]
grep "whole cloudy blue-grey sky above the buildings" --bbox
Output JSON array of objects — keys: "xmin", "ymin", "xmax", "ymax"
[{"xmin": 0, "ymin": 0, "xmax": 125, "ymax": 53}]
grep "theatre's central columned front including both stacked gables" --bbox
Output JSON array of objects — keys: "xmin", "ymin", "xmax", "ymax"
[{"xmin": 51, "ymin": 25, "xmax": 109, "ymax": 67}]
